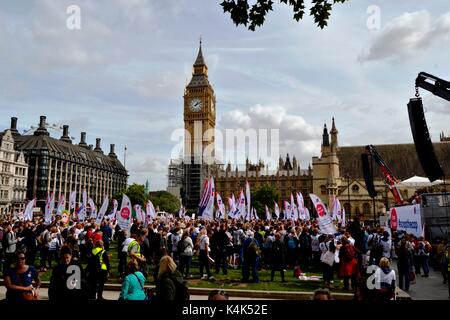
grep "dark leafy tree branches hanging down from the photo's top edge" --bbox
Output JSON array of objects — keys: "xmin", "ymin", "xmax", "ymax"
[{"xmin": 220, "ymin": 0, "xmax": 348, "ymax": 31}]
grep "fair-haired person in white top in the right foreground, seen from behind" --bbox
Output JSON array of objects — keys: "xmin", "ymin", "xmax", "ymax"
[{"xmin": 375, "ymin": 257, "xmax": 396, "ymax": 301}]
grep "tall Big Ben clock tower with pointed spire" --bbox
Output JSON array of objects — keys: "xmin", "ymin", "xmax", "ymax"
[{"xmin": 183, "ymin": 40, "xmax": 216, "ymax": 209}]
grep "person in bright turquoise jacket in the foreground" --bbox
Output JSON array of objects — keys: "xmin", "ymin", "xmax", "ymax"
[{"xmin": 119, "ymin": 259, "xmax": 147, "ymax": 300}]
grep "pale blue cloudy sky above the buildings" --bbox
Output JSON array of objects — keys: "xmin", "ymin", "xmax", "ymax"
[{"xmin": 0, "ymin": 0, "xmax": 450, "ymax": 190}]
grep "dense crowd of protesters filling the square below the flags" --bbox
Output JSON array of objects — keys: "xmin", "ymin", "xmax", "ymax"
[{"xmin": 0, "ymin": 211, "xmax": 450, "ymax": 300}]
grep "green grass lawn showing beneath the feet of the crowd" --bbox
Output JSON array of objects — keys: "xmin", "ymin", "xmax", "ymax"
[{"xmin": 37, "ymin": 242, "xmax": 345, "ymax": 292}]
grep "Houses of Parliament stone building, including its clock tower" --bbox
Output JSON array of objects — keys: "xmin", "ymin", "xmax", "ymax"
[{"xmin": 168, "ymin": 43, "xmax": 450, "ymax": 220}]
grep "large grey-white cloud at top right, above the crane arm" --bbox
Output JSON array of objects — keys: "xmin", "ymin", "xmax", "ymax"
[{"xmin": 359, "ymin": 10, "xmax": 450, "ymax": 62}]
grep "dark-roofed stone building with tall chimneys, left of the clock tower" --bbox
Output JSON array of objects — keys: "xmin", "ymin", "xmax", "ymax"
[{"xmin": 4, "ymin": 116, "xmax": 128, "ymax": 208}]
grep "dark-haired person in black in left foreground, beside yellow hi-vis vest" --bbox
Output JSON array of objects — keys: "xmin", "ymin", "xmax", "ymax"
[{"xmin": 48, "ymin": 246, "xmax": 88, "ymax": 302}]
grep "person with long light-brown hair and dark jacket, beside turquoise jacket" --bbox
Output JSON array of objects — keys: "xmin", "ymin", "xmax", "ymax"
[{"xmin": 156, "ymin": 255, "xmax": 189, "ymax": 302}]
